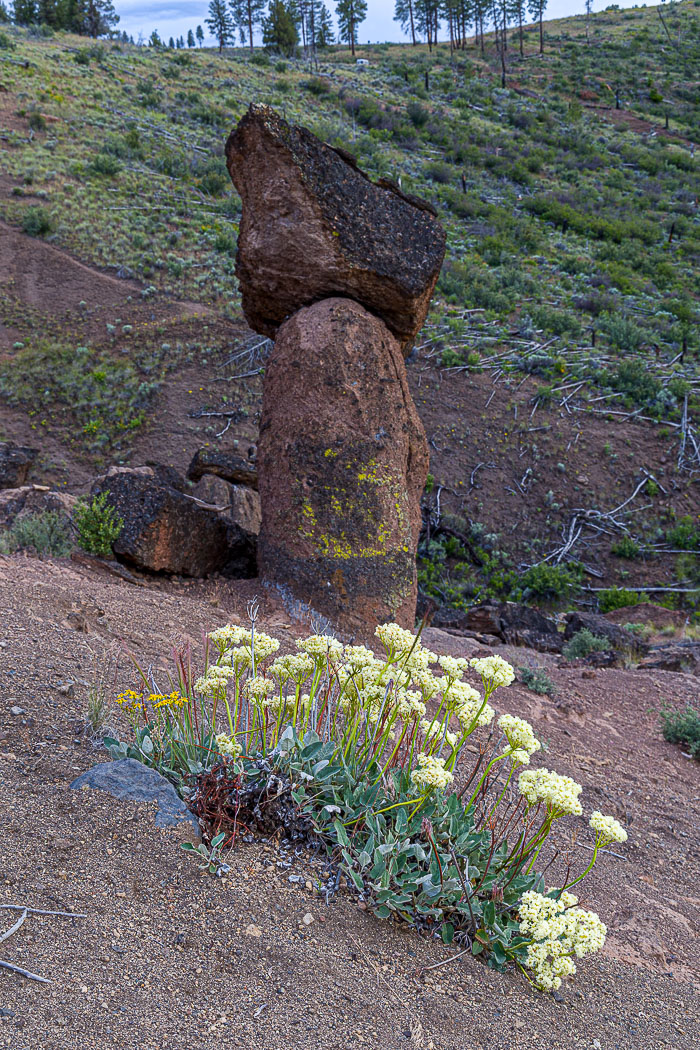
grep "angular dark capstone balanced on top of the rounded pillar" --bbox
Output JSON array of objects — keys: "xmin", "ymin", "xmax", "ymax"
[{"xmin": 226, "ymin": 104, "xmax": 445, "ymax": 351}]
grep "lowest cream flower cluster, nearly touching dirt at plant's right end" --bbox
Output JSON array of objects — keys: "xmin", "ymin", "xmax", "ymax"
[{"xmin": 518, "ymin": 890, "xmax": 608, "ymax": 991}]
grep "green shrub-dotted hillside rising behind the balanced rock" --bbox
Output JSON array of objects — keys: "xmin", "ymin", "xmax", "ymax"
[{"xmin": 0, "ymin": 6, "xmax": 700, "ymax": 613}]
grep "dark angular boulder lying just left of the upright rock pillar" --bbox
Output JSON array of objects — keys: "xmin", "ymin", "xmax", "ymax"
[{"xmin": 92, "ymin": 467, "xmax": 255, "ymax": 578}]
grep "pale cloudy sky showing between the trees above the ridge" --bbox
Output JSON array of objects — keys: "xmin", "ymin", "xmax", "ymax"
[{"xmin": 114, "ymin": 0, "xmax": 663, "ymax": 43}]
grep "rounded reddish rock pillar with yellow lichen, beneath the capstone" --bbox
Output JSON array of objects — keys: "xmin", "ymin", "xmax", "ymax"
[{"xmin": 258, "ymin": 298, "xmax": 428, "ymax": 633}]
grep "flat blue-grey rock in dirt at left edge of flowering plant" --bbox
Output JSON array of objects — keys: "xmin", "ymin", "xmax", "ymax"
[{"xmin": 70, "ymin": 758, "xmax": 200, "ymax": 835}]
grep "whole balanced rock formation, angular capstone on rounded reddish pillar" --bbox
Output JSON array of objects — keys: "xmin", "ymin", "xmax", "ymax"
[{"xmin": 226, "ymin": 105, "xmax": 445, "ymax": 634}]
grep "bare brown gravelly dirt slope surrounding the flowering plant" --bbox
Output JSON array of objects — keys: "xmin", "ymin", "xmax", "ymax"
[{"xmin": 0, "ymin": 557, "xmax": 700, "ymax": 1050}]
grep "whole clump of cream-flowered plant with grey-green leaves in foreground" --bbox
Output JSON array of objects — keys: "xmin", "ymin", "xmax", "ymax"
[{"xmin": 106, "ymin": 610, "xmax": 627, "ymax": 990}]
